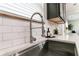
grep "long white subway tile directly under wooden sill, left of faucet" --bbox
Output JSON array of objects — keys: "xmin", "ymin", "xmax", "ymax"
[{"xmin": 3, "ymin": 17, "xmax": 29, "ymax": 26}]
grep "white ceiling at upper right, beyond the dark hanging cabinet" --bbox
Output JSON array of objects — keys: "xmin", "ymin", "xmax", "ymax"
[{"xmin": 66, "ymin": 3, "xmax": 79, "ymax": 20}]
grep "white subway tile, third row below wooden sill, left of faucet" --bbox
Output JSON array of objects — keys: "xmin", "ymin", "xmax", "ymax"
[{"xmin": 3, "ymin": 33, "xmax": 25, "ymax": 40}]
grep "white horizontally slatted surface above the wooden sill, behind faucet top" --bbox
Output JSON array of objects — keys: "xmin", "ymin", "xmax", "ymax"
[{"xmin": 0, "ymin": 3, "xmax": 43, "ymax": 20}]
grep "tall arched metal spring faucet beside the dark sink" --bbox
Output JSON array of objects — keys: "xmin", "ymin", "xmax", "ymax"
[{"xmin": 30, "ymin": 12, "xmax": 44, "ymax": 43}]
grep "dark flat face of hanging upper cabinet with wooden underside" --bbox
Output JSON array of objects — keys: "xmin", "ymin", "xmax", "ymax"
[{"xmin": 47, "ymin": 3, "xmax": 60, "ymax": 19}]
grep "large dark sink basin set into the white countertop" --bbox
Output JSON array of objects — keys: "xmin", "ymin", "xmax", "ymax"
[{"xmin": 21, "ymin": 40, "xmax": 77, "ymax": 56}]
